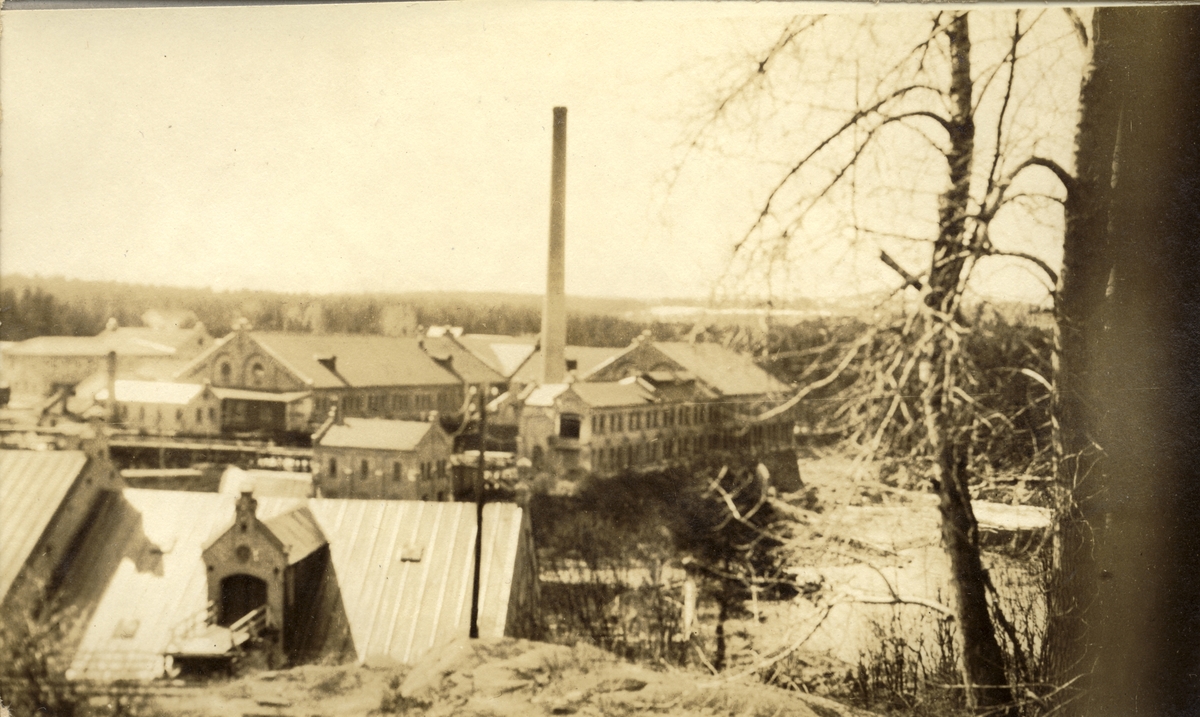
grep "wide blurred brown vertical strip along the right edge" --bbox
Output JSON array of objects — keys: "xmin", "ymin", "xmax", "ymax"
[{"xmin": 1085, "ymin": 6, "xmax": 1200, "ymax": 716}]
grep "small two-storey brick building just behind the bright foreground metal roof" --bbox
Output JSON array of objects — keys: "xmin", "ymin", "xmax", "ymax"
[{"xmin": 312, "ymin": 418, "xmax": 454, "ymax": 500}]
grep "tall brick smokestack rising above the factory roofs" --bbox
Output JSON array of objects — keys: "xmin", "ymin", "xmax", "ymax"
[{"xmin": 541, "ymin": 107, "xmax": 566, "ymax": 384}]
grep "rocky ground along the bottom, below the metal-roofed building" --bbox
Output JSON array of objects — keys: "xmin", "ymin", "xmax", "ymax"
[{"xmin": 146, "ymin": 639, "xmax": 866, "ymax": 717}]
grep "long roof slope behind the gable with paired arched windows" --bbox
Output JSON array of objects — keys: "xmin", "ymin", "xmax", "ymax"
[{"xmin": 250, "ymin": 331, "xmax": 462, "ymax": 388}]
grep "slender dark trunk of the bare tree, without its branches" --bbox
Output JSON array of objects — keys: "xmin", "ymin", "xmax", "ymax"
[{"xmin": 925, "ymin": 12, "xmax": 1013, "ymax": 713}]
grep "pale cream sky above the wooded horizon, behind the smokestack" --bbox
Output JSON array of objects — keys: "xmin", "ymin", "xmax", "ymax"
[{"xmin": 0, "ymin": 2, "xmax": 1078, "ymax": 303}]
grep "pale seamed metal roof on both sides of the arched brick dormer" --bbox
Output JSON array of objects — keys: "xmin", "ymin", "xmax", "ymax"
[{"xmin": 59, "ymin": 488, "xmax": 522, "ymax": 681}]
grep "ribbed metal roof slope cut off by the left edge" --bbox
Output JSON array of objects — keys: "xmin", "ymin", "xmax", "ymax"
[{"xmin": 0, "ymin": 451, "xmax": 88, "ymax": 599}]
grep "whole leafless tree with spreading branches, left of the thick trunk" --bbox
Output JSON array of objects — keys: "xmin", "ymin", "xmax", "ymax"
[{"xmin": 692, "ymin": 11, "xmax": 1078, "ymax": 713}]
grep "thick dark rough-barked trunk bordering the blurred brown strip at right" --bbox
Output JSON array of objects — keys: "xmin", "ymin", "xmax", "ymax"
[{"xmin": 1043, "ymin": 8, "xmax": 1121, "ymax": 712}]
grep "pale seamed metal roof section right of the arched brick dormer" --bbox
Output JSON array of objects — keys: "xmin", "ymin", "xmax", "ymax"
[{"xmin": 308, "ymin": 499, "xmax": 522, "ymax": 663}]
